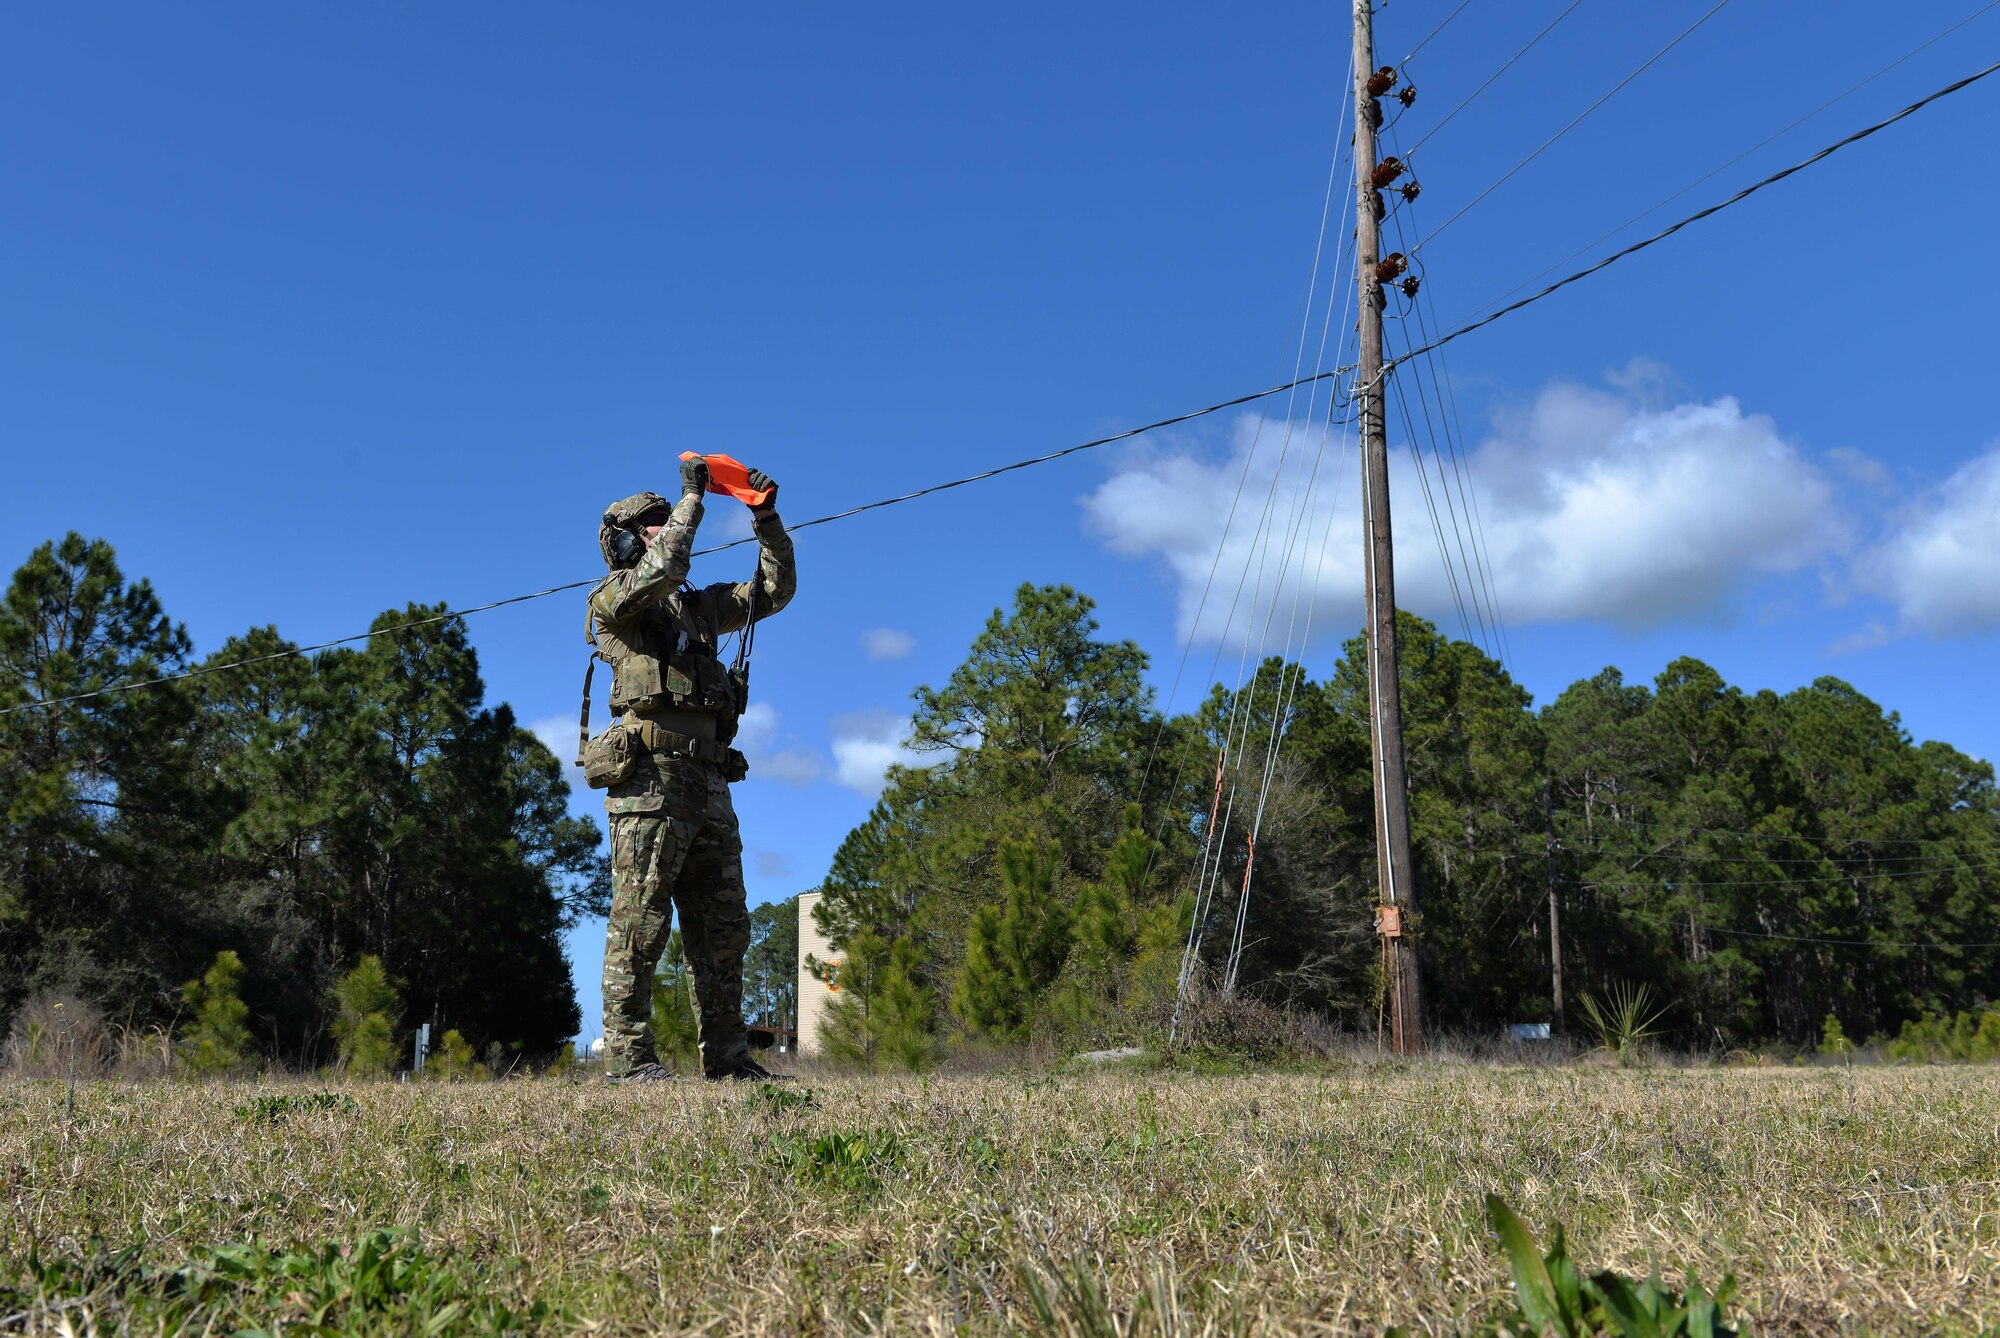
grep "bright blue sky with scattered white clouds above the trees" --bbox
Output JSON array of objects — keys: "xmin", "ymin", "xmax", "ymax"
[{"xmin": 0, "ymin": 0, "xmax": 2000, "ymax": 1036}]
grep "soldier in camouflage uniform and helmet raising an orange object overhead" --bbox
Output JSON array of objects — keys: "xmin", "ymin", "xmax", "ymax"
[{"xmin": 586, "ymin": 458, "xmax": 796, "ymax": 1080}]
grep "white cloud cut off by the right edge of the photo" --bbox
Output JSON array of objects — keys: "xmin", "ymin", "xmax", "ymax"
[{"xmin": 1856, "ymin": 446, "xmax": 2000, "ymax": 634}]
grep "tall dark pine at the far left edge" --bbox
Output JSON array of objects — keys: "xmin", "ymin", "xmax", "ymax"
[{"xmin": 0, "ymin": 532, "xmax": 195, "ymax": 1022}]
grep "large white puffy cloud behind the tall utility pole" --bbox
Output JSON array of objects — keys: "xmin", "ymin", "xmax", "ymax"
[{"xmin": 1084, "ymin": 378, "xmax": 1846, "ymax": 652}]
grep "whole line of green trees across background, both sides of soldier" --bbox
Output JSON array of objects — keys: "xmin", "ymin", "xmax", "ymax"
[{"xmin": 0, "ymin": 534, "xmax": 2000, "ymax": 1066}]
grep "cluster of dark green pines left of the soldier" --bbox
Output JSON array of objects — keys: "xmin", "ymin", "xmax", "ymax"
[{"xmin": 0, "ymin": 534, "xmax": 610, "ymax": 1066}]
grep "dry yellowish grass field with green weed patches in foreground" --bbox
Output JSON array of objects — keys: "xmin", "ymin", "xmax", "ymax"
[{"xmin": 0, "ymin": 1064, "xmax": 2000, "ymax": 1334}]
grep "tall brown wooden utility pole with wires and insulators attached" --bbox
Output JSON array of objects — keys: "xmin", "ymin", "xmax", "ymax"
[{"xmin": 1354, "ymin": 0, "xmax": 1424, "ymax": 1054}]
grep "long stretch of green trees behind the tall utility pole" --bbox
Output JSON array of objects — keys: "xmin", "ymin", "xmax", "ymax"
[{"xmin": 820, "ymin": 586, "xmax": 2000, "ymax": 1066}]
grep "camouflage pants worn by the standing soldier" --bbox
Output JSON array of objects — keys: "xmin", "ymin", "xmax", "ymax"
[{"xmin": 604, "ymin": 754, "xmax": 750, "ymax": 1076}]
